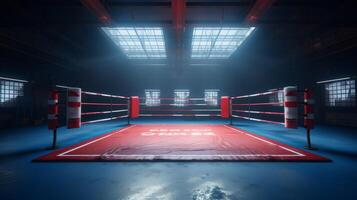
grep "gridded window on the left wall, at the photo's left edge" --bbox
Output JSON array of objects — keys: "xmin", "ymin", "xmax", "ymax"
[{"xmin": 0, "ymin": 78, "xmax": 24, "ymax": 107}]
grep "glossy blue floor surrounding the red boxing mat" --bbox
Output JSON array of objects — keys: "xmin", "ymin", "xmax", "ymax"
[{"xmin": 0, "ymin": 119, "xmax": 357, "ymax": 200}]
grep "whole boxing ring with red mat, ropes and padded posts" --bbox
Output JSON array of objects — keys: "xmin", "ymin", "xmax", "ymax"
[{"xmin": 35, "ymin": 87, "xmax": 329, "ymax": 161}]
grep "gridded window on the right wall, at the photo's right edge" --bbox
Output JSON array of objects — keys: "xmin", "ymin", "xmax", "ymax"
[{"xmin": 325, "ymin": 80, "xmax": 356, "ymax": 107}]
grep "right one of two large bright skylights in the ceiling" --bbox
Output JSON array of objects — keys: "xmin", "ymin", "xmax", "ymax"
[{"xmin": 191, "ymin": 27, "xmax": 254, "ymax": 59}]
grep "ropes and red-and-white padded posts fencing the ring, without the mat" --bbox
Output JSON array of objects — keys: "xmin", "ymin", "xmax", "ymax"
[{"xmin": 48, "ymin": 86, "xmax": 314, "ymax": 149}]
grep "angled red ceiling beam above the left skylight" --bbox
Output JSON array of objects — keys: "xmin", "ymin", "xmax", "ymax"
[{"xmin": 80, "ymin": 0, "xmax": 112, "ymax": 24}]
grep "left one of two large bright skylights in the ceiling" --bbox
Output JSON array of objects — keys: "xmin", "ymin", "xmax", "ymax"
[{"xmin": 102, "ymin": 27, "xmax": 166, "ymax": 59}]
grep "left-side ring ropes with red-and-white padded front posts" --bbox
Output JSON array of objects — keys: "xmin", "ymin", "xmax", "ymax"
[{"xmin": 48, "ymin": 86, "xmax": 131, "ymax": 149}]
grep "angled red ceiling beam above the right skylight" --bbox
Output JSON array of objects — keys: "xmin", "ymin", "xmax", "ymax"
[{"xmin": 245, "ymin": 0, "xmax": 275, "ymax": 24}]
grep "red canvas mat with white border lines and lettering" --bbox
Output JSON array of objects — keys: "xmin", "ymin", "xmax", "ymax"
[{"xmin": 35, "ymin": 124, "xmax": 329, "ymax": 161}]
